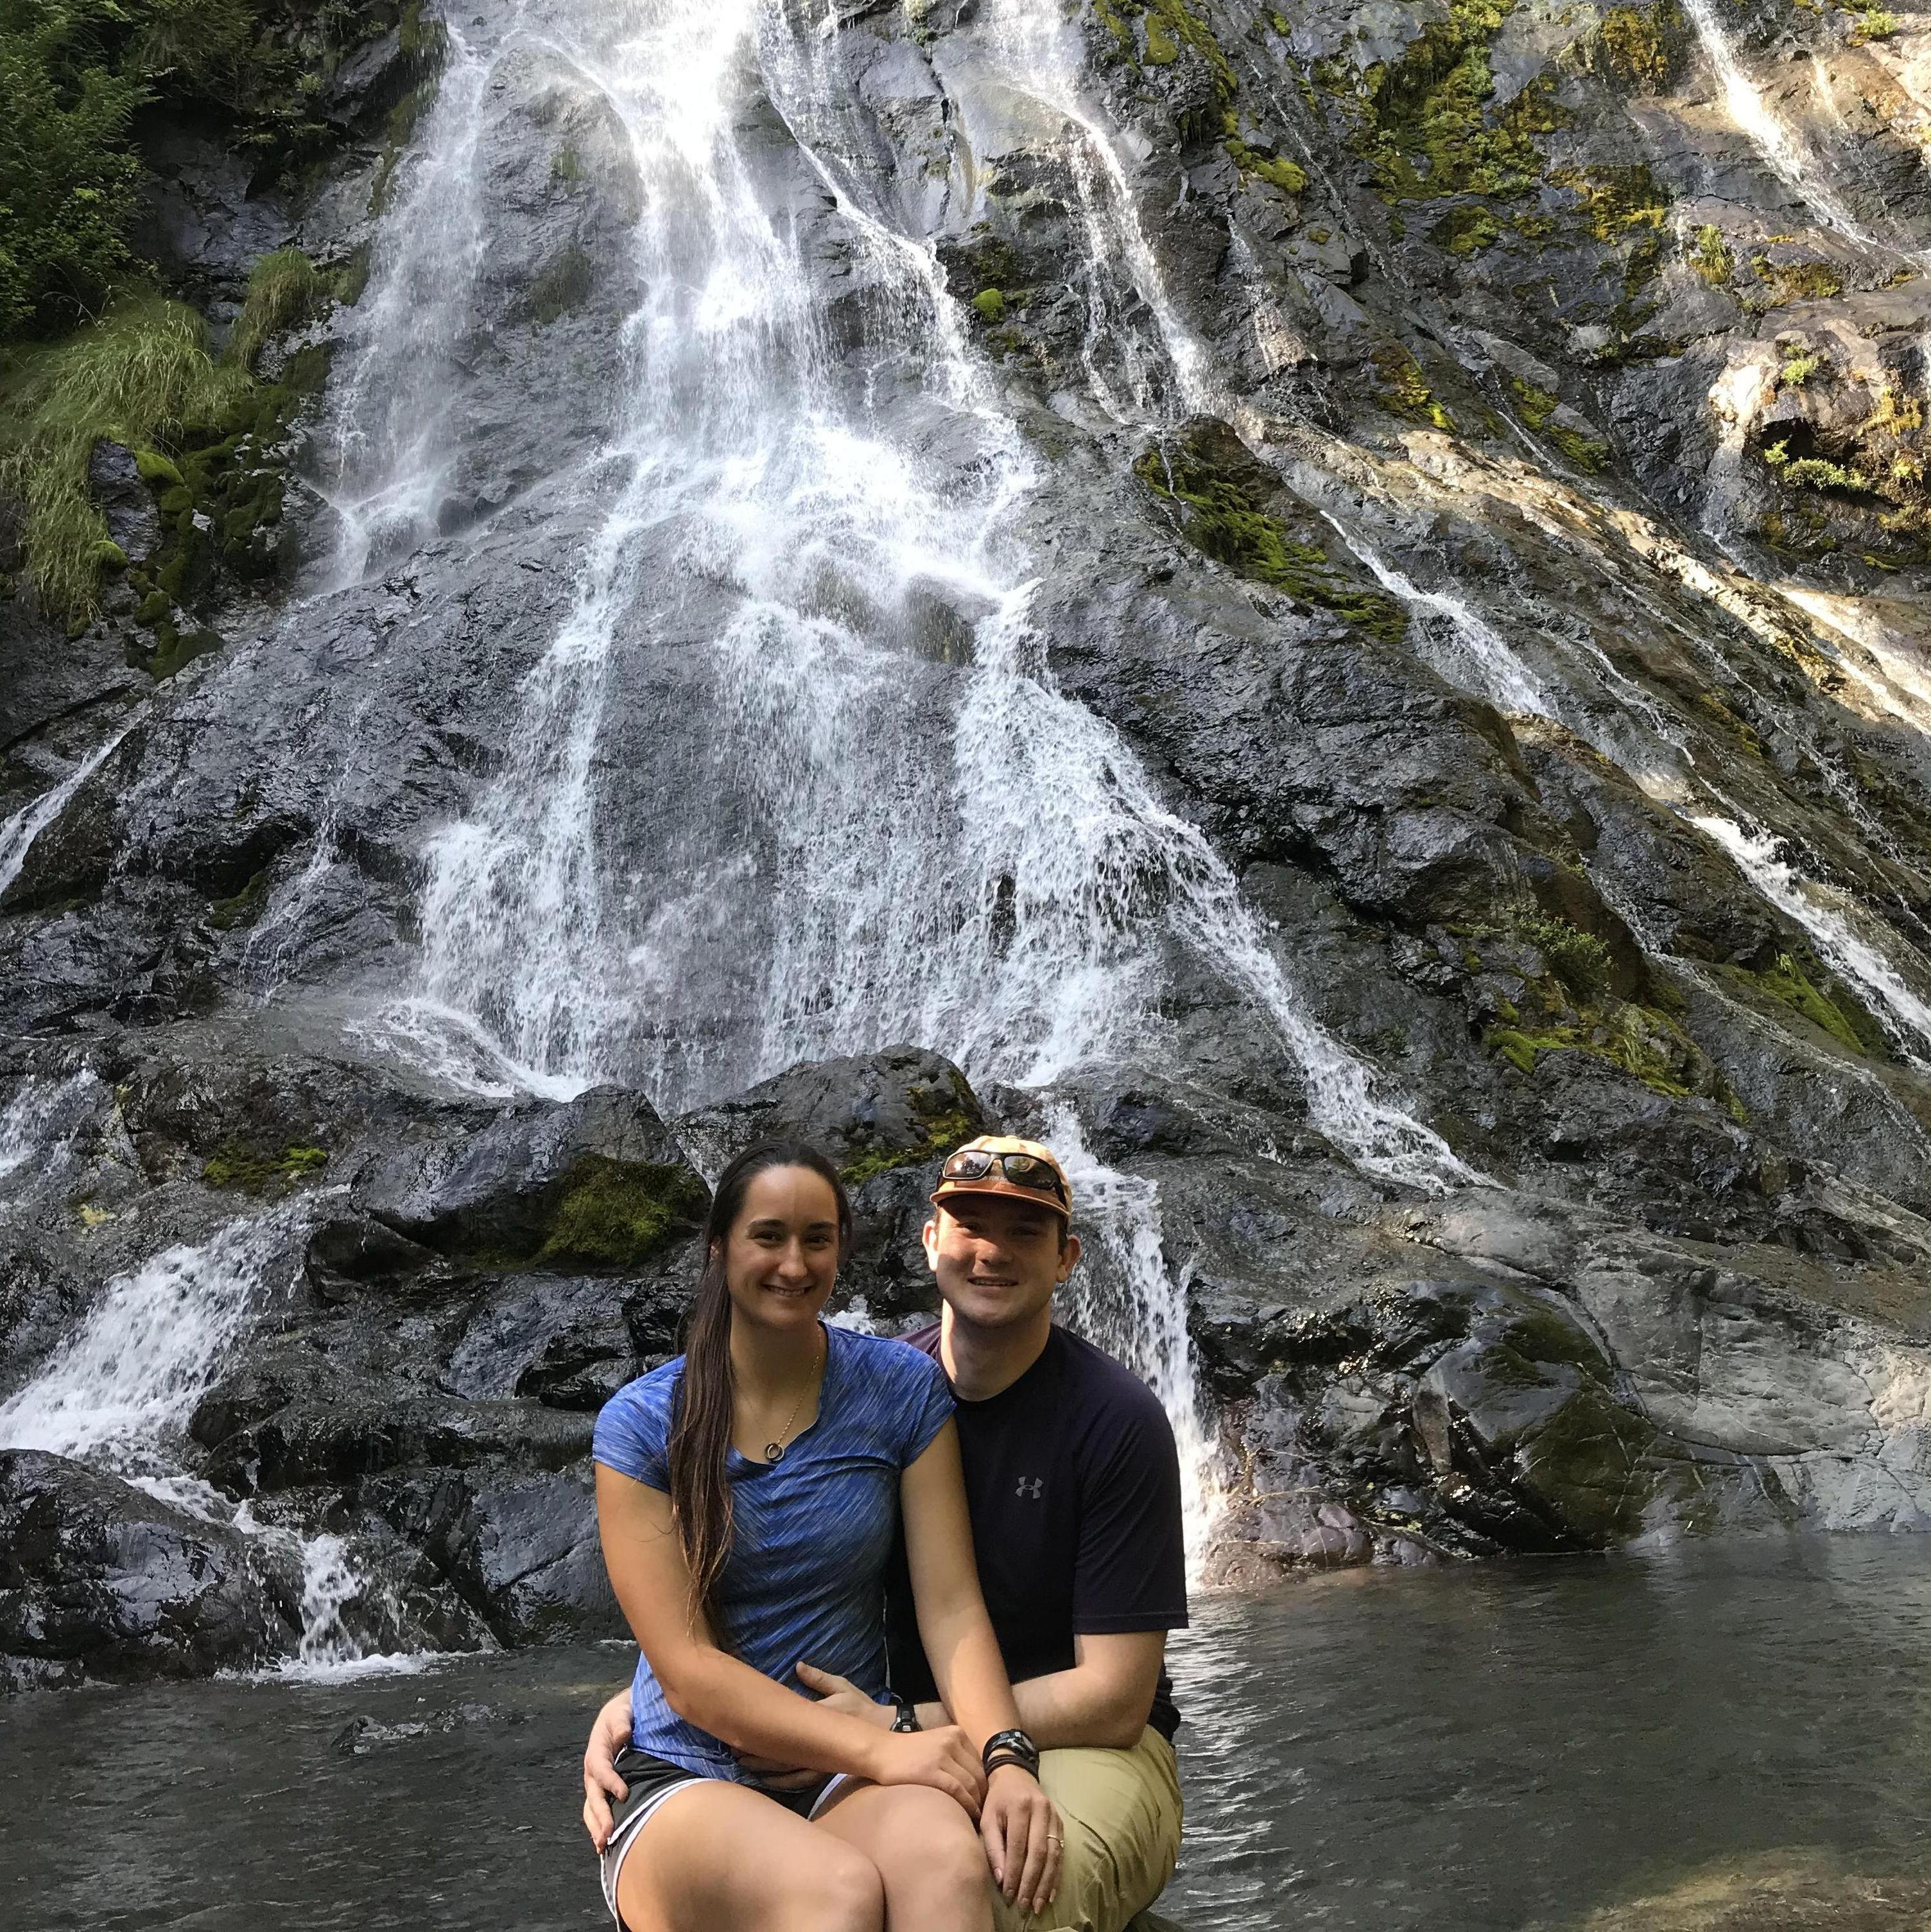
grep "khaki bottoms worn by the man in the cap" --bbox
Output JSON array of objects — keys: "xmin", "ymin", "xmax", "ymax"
[{"xmin": 994, "ymin": 1727, "xmax": 1180, "ymax": 1932}]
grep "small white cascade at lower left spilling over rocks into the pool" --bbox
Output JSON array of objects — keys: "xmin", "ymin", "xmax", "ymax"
[{"xmin": 0, "ymin": 1213, "xmax": 415, "ymax": 1675}]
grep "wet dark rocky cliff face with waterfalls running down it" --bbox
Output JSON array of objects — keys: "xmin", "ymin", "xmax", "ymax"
[{"xmin": 0, "ymin": 0, "xmax": 1931, "ymax": 1677}]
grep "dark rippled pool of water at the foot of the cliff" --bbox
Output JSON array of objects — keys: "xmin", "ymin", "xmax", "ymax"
[{"xmin": 0, "ymin": 1538, "xmax": 1931, "ymax": 1932}]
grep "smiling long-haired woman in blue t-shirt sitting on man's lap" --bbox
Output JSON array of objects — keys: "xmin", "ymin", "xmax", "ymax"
[{"xmin": 594, "ymin": 1142, "xmax": 1060, "ymax": 1932}]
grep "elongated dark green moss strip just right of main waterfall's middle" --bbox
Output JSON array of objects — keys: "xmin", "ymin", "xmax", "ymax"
[{"xmin": 1134, "ymin": 429, "xmax": 1408, "ymax": 643}]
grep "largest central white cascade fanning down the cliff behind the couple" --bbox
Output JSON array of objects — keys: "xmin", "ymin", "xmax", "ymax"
[{"xmin": 351, "ymin": 0, "xmax": 1469, "ymax": 1187}]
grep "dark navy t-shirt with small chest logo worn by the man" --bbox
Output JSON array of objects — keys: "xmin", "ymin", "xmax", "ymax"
[{"xmin": 885, "ymin": 1325, "xmax": 1188, "ymax": 1739}]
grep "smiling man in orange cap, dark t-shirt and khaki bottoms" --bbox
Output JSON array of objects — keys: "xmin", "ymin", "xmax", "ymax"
[{"xmin": 583, "ymin": 1134, "xmax": 1188, "ymax": 1932}]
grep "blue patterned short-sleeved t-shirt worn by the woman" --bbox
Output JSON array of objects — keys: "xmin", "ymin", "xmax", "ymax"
[{"xmin": 593, "ymin": 1325, "xmax": 952, "ymax": 1779}]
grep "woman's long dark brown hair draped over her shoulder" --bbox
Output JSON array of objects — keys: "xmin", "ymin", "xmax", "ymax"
[{"xmin": 670, "ymin": 1140, "xmax": 852, "ymax": 1650}]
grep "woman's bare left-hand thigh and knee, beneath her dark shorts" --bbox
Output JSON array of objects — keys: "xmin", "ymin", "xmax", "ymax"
[{"xmin": 616, "ymin": 1779, "xmax": 884, "ymax": 1932}]
